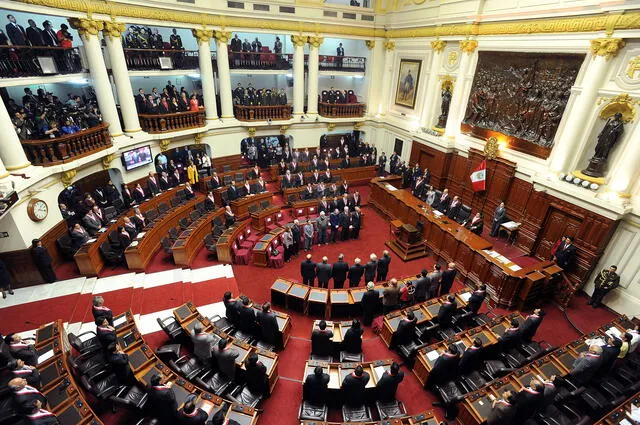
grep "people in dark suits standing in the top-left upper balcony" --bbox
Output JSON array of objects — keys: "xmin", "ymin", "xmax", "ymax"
[{"xmin": 0, "ymin": 14, "xmax": 82, "ymax": 77}]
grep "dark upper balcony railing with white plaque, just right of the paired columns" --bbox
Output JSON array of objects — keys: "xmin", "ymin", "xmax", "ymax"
[{"xmin": 124, "ymin": 49, "xmax": 199, "ymax": 70}]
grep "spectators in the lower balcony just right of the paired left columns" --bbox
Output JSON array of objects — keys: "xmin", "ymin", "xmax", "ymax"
[{"xmin": 134, "ymin": 80, "xmax": 204, "ymax": 115}]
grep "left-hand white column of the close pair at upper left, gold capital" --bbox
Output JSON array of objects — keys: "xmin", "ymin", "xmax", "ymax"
[{"xmin": 69, "ymin": 18, "xmax": 123, "ymax": 137}]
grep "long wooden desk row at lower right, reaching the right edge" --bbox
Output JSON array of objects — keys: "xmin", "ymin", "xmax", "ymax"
[{"xmin": 457, "ymin": 316, "xmax": 633, "ymax": 425}]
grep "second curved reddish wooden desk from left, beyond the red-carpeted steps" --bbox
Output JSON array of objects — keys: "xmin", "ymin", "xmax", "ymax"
[{"xmin": 124, "ymin": 195, "xmax": 203, "ymax": 270}]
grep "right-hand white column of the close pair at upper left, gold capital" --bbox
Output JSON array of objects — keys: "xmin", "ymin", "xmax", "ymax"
[{"xmin": 102, "ymin": 21, "xmax": 142, "ymax": 133}]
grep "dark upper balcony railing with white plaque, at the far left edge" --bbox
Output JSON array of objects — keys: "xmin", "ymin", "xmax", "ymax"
[{"xmin": 0, "ymin": 46, "xmax": 84, "ymax": 78}]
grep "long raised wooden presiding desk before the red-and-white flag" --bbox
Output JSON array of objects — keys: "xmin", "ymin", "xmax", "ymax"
[{"xmin": 369, "ymin": 176, "xmax": 551, "ymax": 307}]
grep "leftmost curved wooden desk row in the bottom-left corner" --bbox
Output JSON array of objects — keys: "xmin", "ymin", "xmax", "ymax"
[{"xmin": 36, "ymin": 320, "xmax": 102, "ymax": 425}]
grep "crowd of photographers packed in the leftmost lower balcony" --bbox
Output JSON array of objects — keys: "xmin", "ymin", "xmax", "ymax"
[{"xmin": 5, "ymin": 87, "xmax": 102, "ymax": 140}]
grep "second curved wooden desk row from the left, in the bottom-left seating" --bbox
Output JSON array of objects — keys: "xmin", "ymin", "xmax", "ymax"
[{"xmin": 113, "ymin": 311, "xmax": 258, "ymax": 425}]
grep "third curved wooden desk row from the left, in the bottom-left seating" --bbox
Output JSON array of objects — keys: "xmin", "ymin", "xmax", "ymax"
[{"xmin": 173, "ymin": 302, "xmax": 278, "ymax": 392}]
